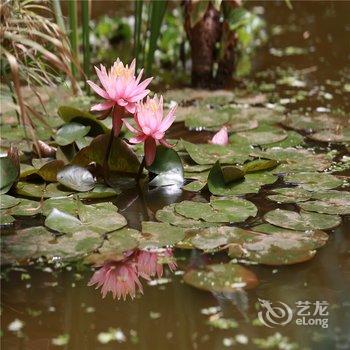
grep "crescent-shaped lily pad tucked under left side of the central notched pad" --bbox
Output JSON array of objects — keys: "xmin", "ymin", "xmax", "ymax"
[{"xmin": 156, "ymin": 203, "xmax": 215, "ymax": 228}]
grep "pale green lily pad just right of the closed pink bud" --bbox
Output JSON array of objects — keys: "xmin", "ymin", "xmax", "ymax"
[{"xmin": 238, "ymin": 125, "xmax": 288, "ymax": 145}]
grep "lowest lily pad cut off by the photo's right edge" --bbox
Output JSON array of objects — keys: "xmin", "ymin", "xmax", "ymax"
[{"xmin": 299, "ymin": 190, "xmax": 350, "ymax": 215}]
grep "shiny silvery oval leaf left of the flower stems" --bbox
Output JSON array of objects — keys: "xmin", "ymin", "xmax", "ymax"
[{"xmin": 57, "ymin": 165, "xmax": 95, "ymax": 192}]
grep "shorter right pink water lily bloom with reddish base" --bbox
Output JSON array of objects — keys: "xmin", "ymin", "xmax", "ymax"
[{"xmin": 124, "ymin": 95, "xmax": 176, "ymax": 166}]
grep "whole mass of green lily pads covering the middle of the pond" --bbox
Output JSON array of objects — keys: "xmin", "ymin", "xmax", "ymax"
[{"xmin": 0, "ymin": 85, "xmax": 350, "ymax": 292}]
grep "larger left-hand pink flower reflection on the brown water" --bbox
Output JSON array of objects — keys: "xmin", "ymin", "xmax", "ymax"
[{"xmin": 88, "ymin": 260, "xmax": 143, "ymax": 300}]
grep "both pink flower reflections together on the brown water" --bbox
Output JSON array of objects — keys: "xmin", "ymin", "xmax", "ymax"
[{"xmin": 88, "ymin": 248, "xmax": 177, "ymax": 300}]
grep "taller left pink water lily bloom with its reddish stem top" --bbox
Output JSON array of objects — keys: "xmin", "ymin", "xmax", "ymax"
[{"xmin": 87, "ymin": 58, "xmax": 153, "ymax": 136}]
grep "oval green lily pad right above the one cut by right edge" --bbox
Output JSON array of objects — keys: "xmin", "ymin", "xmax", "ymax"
[{"xmin": 284, "ymin": 172, "xmax": 343, "ymax": 191}]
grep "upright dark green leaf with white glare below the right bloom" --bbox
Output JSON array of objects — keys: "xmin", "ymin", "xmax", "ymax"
[{"xmin": 147, "ymin": 145, "xmax": 184, "ymax": 186}]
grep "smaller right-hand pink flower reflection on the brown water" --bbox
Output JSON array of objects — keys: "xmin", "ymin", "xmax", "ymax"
[{"xmin": 136, "ymin": 249, "xmax": 177, "ymax": 279}]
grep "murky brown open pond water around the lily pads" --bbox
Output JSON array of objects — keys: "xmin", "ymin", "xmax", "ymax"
[{"xmin": 1, "ymin": 2, "xmax": 350, "ymax": 350}]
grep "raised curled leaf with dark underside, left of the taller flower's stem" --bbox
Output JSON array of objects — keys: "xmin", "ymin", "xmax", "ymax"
[{"xmin": 58, "ymin": 106, "xmax": 108, "ymax": 136}]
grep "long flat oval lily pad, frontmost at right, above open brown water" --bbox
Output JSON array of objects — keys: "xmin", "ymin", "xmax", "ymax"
[{"xmin": 264, "ymin": 209, "xmax": 341, "ymax": 231}]
